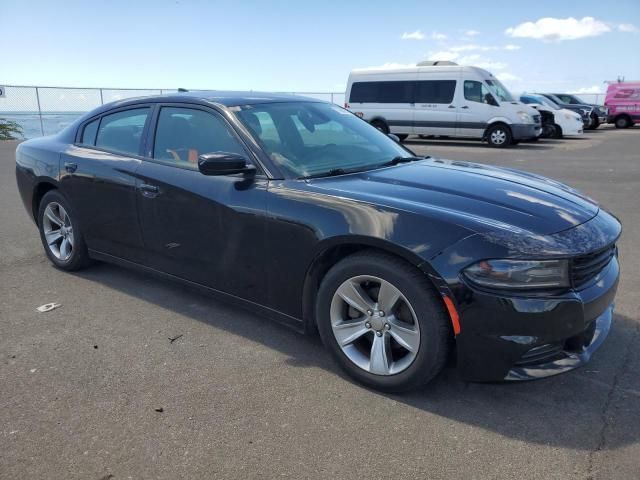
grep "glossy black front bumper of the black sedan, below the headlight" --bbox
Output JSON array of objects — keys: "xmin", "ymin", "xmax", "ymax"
[{"xmin": 456, "ymin": 257, "xmax": 619, "ymax": 381}]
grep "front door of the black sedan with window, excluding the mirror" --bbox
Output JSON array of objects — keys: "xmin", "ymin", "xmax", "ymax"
[{"xmin": 137, "ymin": 104, "xmax": 267, "ymax": 303}]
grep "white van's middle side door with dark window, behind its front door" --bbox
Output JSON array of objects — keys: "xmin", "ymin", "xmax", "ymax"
[{"xmin": 413, "ymin": 77, "xmax": 458, "ymax": 135}]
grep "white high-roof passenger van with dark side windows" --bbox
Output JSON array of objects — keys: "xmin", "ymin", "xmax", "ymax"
[{"xmin": 345, "ymin": 62, "xmax": 541, "ymax": 147}]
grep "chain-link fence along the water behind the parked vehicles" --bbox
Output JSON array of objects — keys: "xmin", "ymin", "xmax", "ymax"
[{"xmin": 0, "ymin": 85, "xmax": 604, "ymax": 138}]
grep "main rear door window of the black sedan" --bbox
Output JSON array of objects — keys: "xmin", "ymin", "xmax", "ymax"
[{"xmin": 96, "ymin": 108, "xmax": 149, "ymax": 155}]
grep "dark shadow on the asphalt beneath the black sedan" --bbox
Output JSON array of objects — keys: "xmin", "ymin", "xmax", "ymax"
[{"xmin": 74, "ymin": 263, "xmax": 640, "ymax": 451}]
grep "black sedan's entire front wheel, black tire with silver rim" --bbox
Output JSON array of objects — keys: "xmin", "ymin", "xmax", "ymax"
[{"xmin": 316, "ymin": 251, "xmax": 453, "ymax": 392}]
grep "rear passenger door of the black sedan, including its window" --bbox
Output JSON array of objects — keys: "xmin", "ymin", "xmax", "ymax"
[{"xmin": 60, "ymin": 105, "xmax": 151, "ymax": 261}]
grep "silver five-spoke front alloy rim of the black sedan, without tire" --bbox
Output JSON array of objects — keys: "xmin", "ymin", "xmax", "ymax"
[{"xmin": 330, "ymin": 275, "xmax": 420, "ymax": 375}]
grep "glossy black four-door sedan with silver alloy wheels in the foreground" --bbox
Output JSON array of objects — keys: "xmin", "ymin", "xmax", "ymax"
[{"xmin": 16, "ymin": 92, "xmax": 621, "ymax": 391}]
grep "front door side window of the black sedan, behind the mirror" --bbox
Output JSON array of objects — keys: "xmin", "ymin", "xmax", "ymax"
[{"xmin": 153, "ymin": 107, "xmax": 247, "ymax": 169}]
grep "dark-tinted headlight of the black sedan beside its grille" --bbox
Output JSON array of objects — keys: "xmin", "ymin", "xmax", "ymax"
[{"xmin": 464, "ymin": 260, "xmax": 569, "ymax": 289}]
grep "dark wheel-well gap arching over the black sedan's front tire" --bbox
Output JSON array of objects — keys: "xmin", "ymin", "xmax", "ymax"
[{"xmin": 302, "ymin": 243, "xmax": 435, "ymax": 332}]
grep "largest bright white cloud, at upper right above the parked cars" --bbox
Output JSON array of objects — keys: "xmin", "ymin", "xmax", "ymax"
[{"xmin": 505, "ymin": 17, "xmax": 611, "ymax": 41}]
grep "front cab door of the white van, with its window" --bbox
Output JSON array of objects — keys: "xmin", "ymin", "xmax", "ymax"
[{"xmin": 456, "ymin": 80, "xmax": 500, "ymax": 138}]
